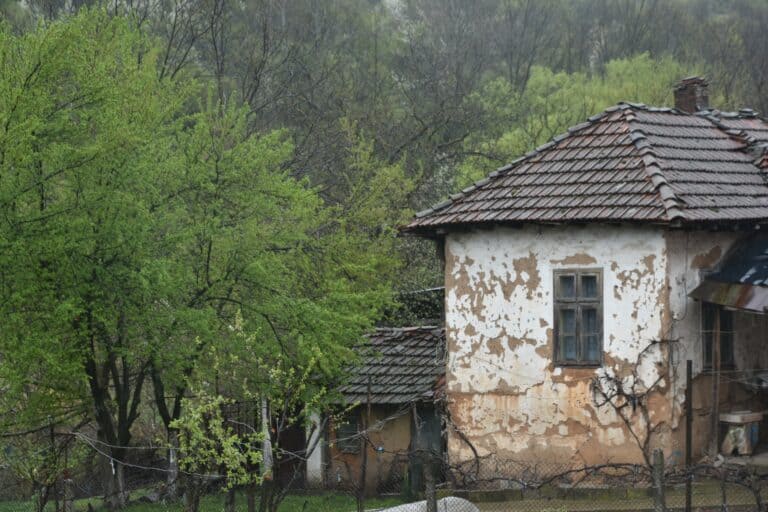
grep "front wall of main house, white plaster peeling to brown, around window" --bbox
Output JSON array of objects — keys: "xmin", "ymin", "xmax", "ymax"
[{"xmin": 445, "ymin": 225, "xmax": 672, "ymax": 463}]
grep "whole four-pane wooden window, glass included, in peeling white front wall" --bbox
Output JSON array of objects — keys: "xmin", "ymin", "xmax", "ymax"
[{"xmin": 554, "ymin": 270, "xmax": 603, "ymax": 366}]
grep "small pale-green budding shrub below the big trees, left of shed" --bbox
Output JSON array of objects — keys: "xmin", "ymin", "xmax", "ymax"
[{"xmin": 172, "ymin": 315, "xmax": 336, "ymax": 512}]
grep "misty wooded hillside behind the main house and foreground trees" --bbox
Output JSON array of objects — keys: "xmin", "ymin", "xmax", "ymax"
[{"xmin": 2, "ymin": 0, "xmax": 768, "ymax": 289}]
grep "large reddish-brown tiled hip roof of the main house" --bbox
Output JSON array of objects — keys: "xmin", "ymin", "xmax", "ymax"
[{"xmin": 404, "ymin": 104, "xmax": 768, "ymax": 233}]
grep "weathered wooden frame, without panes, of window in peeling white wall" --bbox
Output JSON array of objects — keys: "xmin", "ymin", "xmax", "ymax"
[{"xmin": 552, "ymin": 268, "xmax": 605, "ymax": 368}]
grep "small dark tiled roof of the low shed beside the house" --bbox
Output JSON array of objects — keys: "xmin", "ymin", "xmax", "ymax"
[{"xmin": 339, "ymin": 327, "xmax": 445, "ymax": 404}]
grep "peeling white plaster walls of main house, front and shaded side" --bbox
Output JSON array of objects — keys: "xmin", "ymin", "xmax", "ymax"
[{"xmin": 445, "ymin": 224, "xmax": 768, "ymax": 463}]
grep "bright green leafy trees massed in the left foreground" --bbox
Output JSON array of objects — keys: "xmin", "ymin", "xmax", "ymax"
[{"xmin": 0, "ymin": 10, "xmax": 397, "ymax": 508}]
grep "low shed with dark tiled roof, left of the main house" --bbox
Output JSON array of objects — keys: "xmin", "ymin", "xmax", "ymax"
[{"xmin": 307, "ymin": 327, "xmax": 445, "ymax": 493}]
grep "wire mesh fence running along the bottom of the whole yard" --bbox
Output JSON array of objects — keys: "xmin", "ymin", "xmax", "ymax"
[{"xmin": 0, "ymin": 453, "xmax": 768, "ymax": 512}]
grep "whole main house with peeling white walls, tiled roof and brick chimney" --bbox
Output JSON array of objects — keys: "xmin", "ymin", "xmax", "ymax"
[{"xmin": 405, "ymin": 78, "xmax": 768, "ymax": 464}]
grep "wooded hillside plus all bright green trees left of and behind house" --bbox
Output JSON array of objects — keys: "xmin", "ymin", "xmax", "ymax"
[{"xmin": 0, "ymin": 0, "xmax": 768, "ymax": 508}]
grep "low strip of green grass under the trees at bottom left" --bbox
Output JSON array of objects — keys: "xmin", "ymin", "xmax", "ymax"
[{"xmin": 0, "ymin": 493, "xmax": 402, "ymax": 512}]
